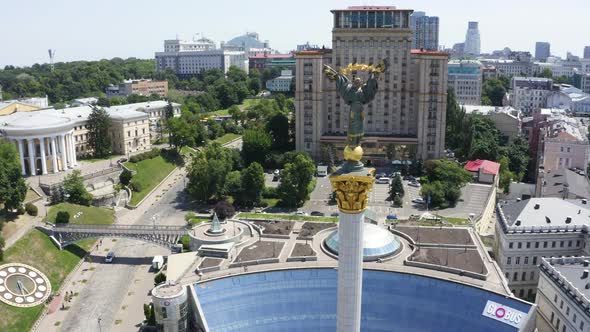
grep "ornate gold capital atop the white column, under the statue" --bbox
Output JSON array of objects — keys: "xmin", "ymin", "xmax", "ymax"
[{"xmin": 330, "ymin": 174, "xmax": 373, "ymax": 214}]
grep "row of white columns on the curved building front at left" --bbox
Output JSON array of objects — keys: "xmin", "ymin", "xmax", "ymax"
[{"xmin": 7, "ymin": 130, "xmax": 78, "ymax": 175}]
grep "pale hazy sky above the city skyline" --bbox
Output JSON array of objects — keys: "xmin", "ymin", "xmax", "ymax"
[{"xmin": 0, "ymin": 0, "xmax": 590, "ymax": 68}]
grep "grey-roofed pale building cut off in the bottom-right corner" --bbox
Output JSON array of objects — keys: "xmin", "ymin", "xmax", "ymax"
[{"xmin": 535, "ymin": 257, "xmax": 590, "ymax": 332}]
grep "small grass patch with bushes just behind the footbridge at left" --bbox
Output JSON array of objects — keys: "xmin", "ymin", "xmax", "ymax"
[{"xmin": 45, "ymin": 203, "xmax": 115, "ymax": 225}]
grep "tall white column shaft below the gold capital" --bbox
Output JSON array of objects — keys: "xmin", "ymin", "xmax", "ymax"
[{"xmin": 336, "ymin": 211, "xmax": 365, "ymax": 332}]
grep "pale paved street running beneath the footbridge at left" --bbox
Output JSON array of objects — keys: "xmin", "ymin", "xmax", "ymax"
[{"xmin": 45, "ymin": 170, "xmax": 190, "ymax": 331}]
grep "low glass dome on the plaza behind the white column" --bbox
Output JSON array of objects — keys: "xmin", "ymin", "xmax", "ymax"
[{"xmin": 325, "ymin": 223, "xmax": 401, "ymax": 262}]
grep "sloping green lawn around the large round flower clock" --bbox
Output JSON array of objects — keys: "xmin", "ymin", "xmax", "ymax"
[{"xmin": 0, "ymin": 229, "xmax": 96, "ymax": 332}]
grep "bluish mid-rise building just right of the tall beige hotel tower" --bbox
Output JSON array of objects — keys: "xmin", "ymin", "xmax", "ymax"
[{"xmin": 448, "ymin": 60, "xmax": 483, "ymax": 105}]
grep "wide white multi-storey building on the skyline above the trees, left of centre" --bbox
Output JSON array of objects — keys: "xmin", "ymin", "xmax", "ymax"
[{"xmin": 156, "ymin": 38, "xmax": 248, "ymax": 76}]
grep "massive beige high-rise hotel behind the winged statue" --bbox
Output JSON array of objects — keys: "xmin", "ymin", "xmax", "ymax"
[{"xmin": 295, "ymin": 6, "xmax": 448, "ymax": 165}]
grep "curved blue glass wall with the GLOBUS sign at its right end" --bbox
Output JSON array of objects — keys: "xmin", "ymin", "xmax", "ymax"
[{"xmin": 194, "ymin": 268, "xmax": 534, "ymax": 332}]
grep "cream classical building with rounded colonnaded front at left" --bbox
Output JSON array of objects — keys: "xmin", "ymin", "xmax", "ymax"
[{"xmin": 0, "ymin": 105, "xmax": 151, "ymax": 175}]
